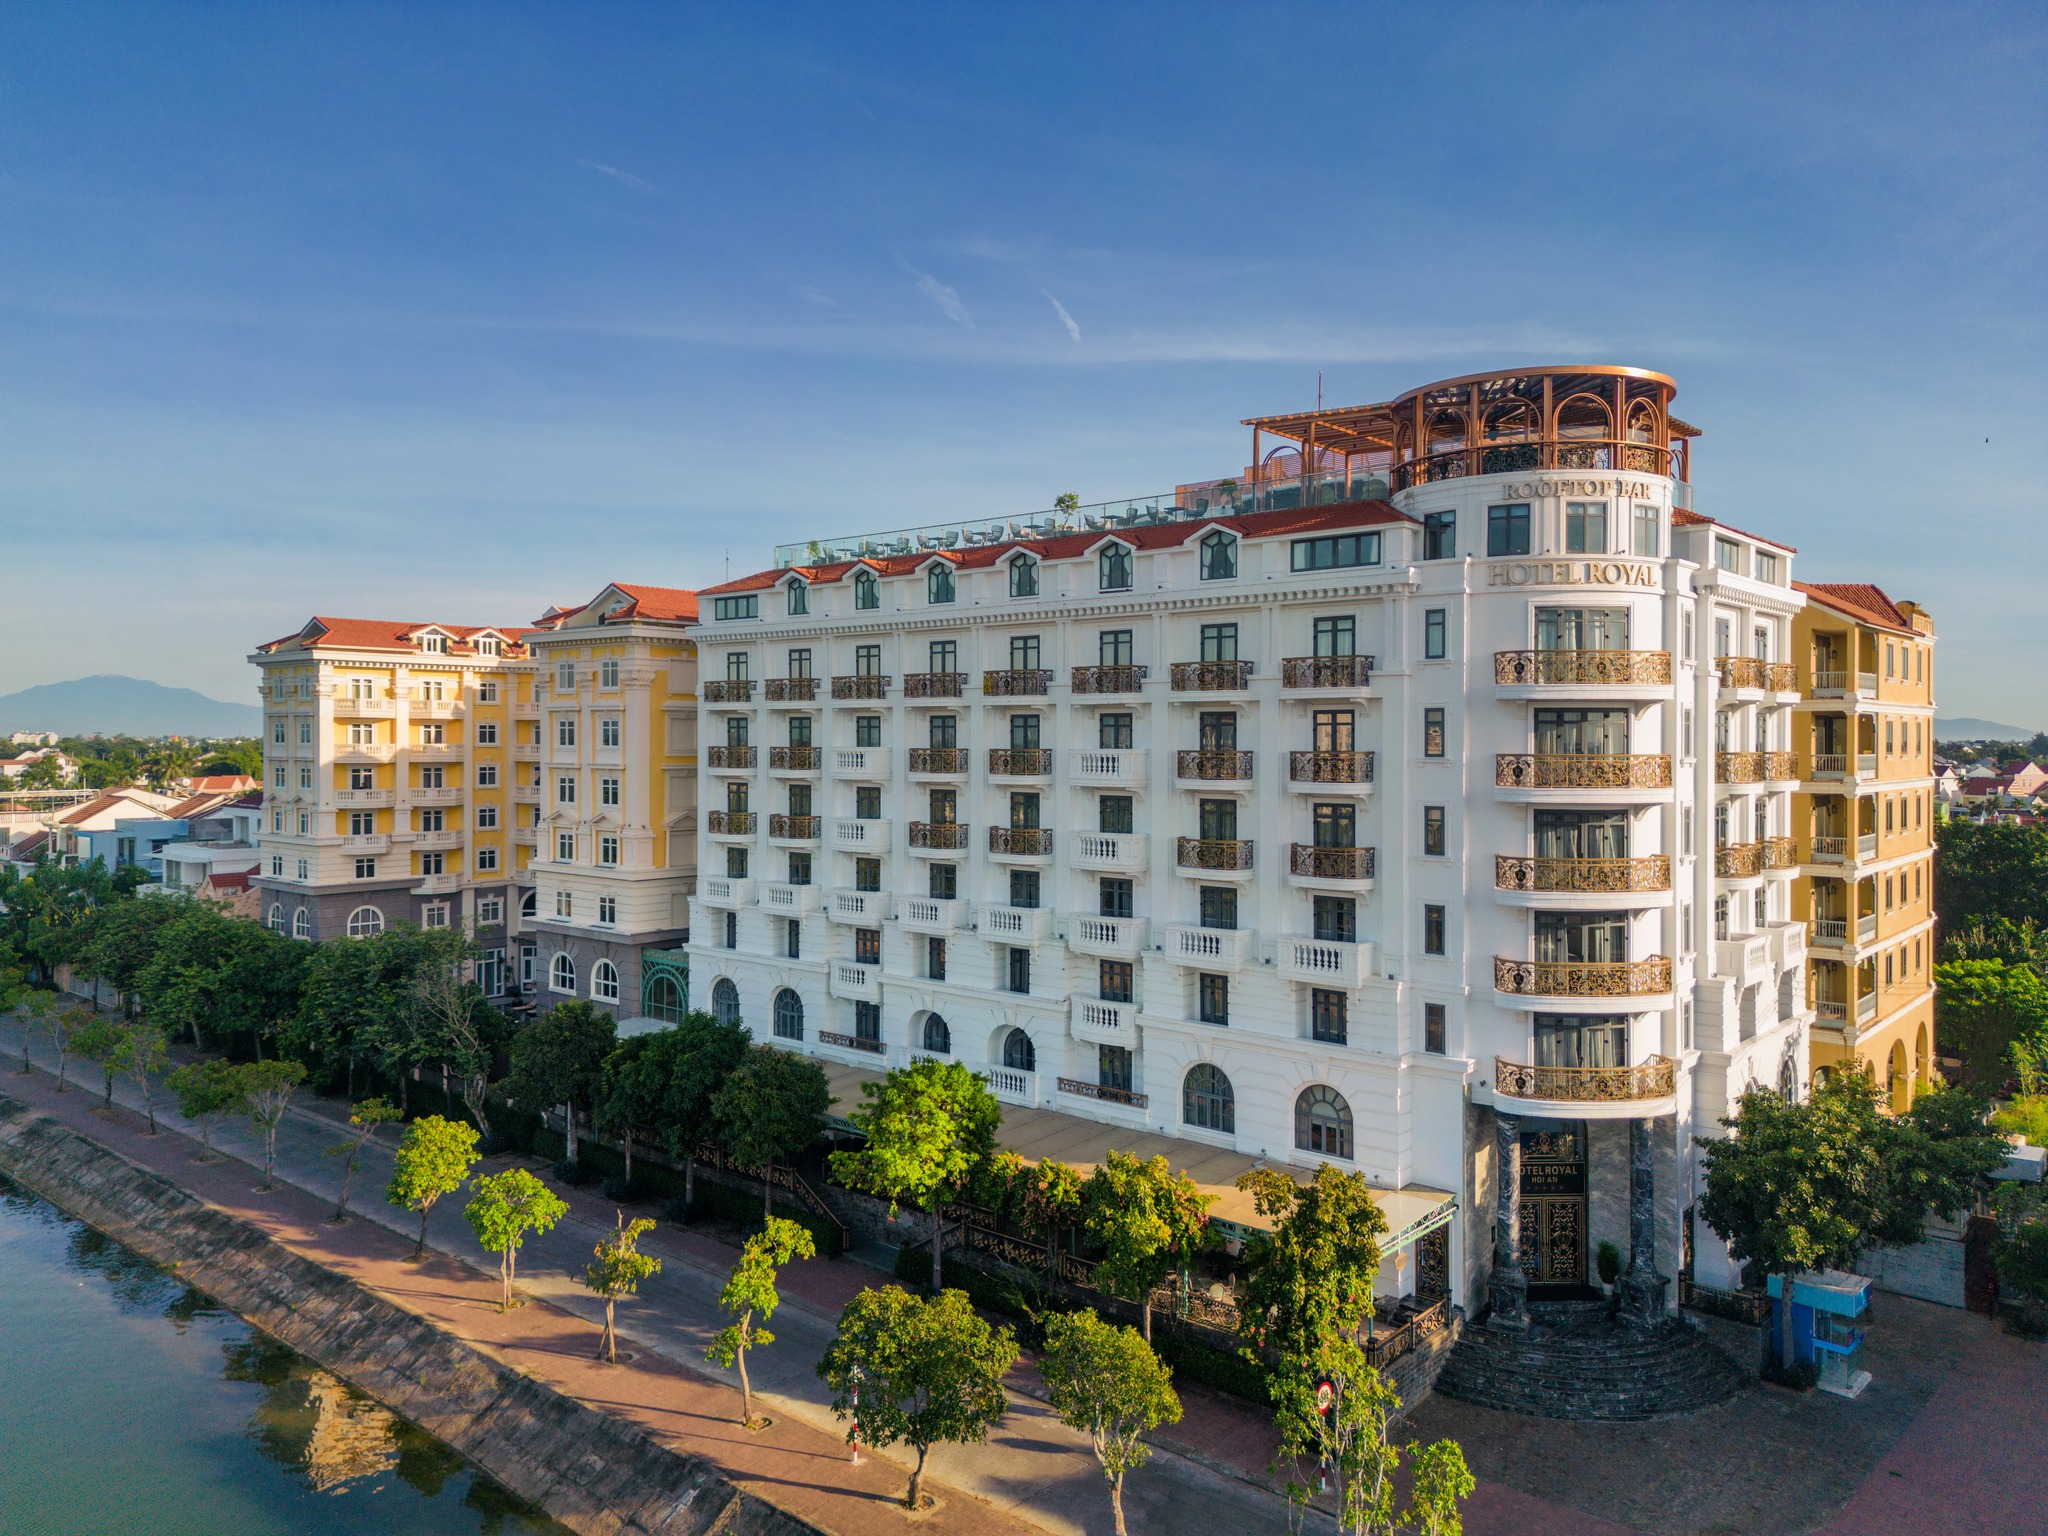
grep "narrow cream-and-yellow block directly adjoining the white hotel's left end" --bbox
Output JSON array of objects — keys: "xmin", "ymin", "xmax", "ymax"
[{"xmin": 518, "ymin": 584, "xmax": 696, "ymax": 1032}]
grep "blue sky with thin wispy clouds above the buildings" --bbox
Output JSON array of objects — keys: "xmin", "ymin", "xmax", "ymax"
[{"xmin": 0, "ymin": 2, "xmax": 2048, "ymax": 725}]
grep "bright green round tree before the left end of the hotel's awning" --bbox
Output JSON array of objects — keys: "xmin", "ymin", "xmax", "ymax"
[{"xmin": 831, "ymin": 1061, "xmax": 1004, "ymax": 1294}]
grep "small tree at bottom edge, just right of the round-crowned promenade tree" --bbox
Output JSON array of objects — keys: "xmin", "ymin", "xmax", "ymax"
[{"xmin": 1038, "ymin": 1313, "xmax": 1180, "ymax": 1536}]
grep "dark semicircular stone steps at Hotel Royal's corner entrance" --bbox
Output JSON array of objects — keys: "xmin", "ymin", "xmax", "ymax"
[{"xmin": 1436, "ymin": 1300, "xmax": 1749, "ymax": 1419}]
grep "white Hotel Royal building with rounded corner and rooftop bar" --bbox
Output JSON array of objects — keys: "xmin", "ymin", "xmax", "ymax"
[{"xmin": 690, "ymin": 367, "xmax": 1810, "ymax": 1315}]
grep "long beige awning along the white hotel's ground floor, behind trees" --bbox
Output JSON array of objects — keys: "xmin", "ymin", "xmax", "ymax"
[{"xmin": 819, "ymin": 1061, "xmax": 1458, "ymax": 1253}]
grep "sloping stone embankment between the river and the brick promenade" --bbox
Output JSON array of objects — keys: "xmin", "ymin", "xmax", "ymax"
[{"xmin": 0, "ymin": 1096, "xmax": 819, "ymax": 1536}]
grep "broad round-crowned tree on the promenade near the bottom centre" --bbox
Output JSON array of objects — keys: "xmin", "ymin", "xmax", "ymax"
[{"xmin": 817, "ymin": 1286, "xmax": 1018, "ymax": 1509}]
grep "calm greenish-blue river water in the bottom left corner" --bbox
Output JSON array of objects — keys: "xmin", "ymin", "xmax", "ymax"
[{"xmin": 0, "ymin": 1180, "xmax": 569, "ymax": 1536}]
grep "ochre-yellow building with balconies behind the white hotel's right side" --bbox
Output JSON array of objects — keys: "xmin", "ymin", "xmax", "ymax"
[{"xmin": 1794, "ymin": 582, "xmax": 1935, "ymax": 1110}]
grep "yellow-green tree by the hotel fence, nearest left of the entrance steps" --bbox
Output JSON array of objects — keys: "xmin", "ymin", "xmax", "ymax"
[{"xmin": 1237, "ymin": 1163, "xmax": 1386, "ymax": 1360}]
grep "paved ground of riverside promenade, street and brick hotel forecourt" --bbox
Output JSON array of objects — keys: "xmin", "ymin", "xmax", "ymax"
[{"xmin": 0, "ymin": 1022, "xmax": 2048, "ymax": 1536}]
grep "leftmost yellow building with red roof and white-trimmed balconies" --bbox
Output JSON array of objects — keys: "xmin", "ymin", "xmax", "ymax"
[{"xmin": 250, "ymin": 616, "xmax": 539, "ymax": 995}]
